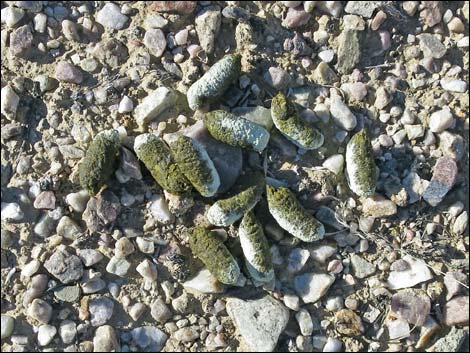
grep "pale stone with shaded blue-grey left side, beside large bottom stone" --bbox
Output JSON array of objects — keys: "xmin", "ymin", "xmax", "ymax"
[{"xmin": 294, "ymin": 273, "xmax": 335, "ymax": 304}]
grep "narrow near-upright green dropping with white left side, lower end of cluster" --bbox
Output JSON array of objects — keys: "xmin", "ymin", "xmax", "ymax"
[{"xmin": 238, "ymin": 211, "xmax": 274, "ymax": 283}]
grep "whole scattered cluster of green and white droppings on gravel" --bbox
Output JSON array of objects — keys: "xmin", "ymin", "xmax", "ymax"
[{"xmin": 79, "ymin": 55, "xmax": 376, "ymax": 288}]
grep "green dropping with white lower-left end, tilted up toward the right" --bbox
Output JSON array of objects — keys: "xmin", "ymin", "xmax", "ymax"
[{"xmin": 207, "ymin": 172, "xmax": 265, "ymax": 227}]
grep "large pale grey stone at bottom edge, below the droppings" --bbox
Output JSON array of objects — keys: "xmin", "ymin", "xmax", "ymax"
[{"xmin": 226, "ymin": 295, "xmax": 289, "ymax": 352}]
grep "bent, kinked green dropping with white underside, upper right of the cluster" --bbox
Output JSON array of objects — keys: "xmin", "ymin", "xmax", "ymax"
[{"xmin": 271, "ymin": 93, "xmax": 324, "ymax": 150}]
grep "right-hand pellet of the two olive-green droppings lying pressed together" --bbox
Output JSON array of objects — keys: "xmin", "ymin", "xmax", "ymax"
[{"xmin": 170, "ymin": 135, "xmax": 220, "ymax": 197}]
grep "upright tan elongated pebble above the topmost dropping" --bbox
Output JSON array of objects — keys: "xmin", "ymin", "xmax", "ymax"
[{"xmin": 194, "ymin": 7, "xmax": 222, "ymax": 54}]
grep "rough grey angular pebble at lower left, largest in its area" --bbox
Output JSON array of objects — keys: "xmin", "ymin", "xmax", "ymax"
[{"xmin": 44, "ymin": 250, "xmax": 83, "ymax": 284}]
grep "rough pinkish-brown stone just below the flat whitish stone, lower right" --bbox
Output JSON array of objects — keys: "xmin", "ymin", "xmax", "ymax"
[{"xmin": 391, "ymin": 289, "xmax": 431, "ymax": 326}]
